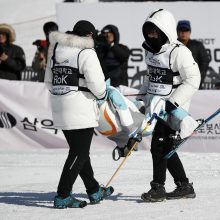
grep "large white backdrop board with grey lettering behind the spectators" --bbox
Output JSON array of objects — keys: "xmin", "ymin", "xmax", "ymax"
[{"xmin": 57, "ymin": 2, "xmax": 220, "ymax": 86}]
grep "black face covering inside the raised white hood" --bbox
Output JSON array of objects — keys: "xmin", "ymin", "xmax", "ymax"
[{"xmin": 142, "ymin": 22, "xmax": 168, "ymax": 53}]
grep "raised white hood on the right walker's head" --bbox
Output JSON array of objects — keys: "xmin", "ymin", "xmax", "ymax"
[{"xmin": 145, "ymin": 9, "xmax": 177, "ymax": 43}]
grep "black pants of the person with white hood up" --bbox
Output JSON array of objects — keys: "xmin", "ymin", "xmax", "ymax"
[{"xmin": 151, "ymin": 121, "xmax": 188, "ymax": 185}]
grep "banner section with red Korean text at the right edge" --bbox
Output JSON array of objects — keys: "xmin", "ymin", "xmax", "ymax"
[{"xmin": 182, "ymin": 90, "xmax": 220, "ymax": 152}]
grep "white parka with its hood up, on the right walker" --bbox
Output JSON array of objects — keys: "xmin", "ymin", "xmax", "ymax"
[{"xmin": 140, "ymin": 10, "xmax": 201, "ymax": 109}]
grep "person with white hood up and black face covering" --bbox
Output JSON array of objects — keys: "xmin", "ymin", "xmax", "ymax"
[{"xmin": 140, "ymin": 9, "xmax": 200, "ymax": 202}]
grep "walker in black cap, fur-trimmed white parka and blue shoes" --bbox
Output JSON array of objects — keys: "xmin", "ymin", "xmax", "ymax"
[{"xmin": 45, "ymin": 20, "xmax": 113, "ymax": 209}]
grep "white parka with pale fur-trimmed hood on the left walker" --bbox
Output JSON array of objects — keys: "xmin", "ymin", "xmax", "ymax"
[{"xmin": 44, "ymin": 32, "xmax": 106, "ymax": 130}]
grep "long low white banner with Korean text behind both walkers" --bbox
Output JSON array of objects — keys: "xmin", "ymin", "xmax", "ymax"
[{"xmin": 0, "ymin": 80, "xmax": 220, "ymax": 152}]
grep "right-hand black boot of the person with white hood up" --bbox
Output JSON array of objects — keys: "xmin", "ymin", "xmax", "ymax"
[{"xmin": 166, "ymin": 182, "xmax": 196, "ymax": 199}]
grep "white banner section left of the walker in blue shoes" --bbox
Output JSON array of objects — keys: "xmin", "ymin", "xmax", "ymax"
[{"xmin": 0, "ymin": 80, "xmax": 67, "ymax": 150}]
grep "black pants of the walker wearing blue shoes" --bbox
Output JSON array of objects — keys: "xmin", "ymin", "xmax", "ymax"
[{"xmin": 57, "ymin": 128, "xmax": 99, "ymax": 198}]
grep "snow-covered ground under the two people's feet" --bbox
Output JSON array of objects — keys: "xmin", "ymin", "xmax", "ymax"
[{"xmin": 0, "ymin": 147, "xmax": 220, "ymax": 220}]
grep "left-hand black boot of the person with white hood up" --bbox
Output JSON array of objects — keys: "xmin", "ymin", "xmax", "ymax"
[{"xmin": 141, "ymin": 182, "xmax": 166, "ymax": 202}]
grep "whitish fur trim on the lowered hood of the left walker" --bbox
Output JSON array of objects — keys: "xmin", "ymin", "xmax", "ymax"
[{"xmin": 49, "ymin": 31, "xmax": 94, "ymax": 49}]
